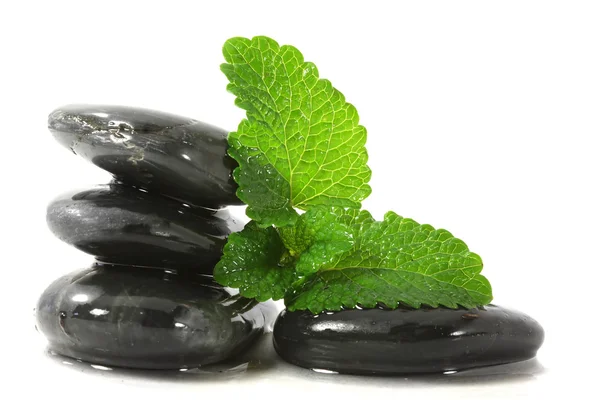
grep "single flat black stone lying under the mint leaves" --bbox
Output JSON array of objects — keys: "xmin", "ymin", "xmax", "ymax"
[{"xmin": 274, "ymin": 305, "xmax": 544, "ymax": 374}]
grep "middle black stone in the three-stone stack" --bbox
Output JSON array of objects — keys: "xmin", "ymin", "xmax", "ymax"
[{"xmin": 46, "ymin": 184, "xmax": 242, "ymax": 273}]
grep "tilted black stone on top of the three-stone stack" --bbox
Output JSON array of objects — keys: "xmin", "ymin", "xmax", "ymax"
[{"xmin": 48, "ymin": 104, "xmax": 242, "ymax": 208}]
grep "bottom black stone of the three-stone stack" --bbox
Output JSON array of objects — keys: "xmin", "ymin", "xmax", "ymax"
[{"xmin": 36, "ymin": 266, "xmax": 273, "ymax": 369}]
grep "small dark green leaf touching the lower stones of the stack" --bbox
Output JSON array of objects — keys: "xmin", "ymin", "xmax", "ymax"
[{"xmin": 214, "ymin": 221, "xmax": 296, "ymax": 301}]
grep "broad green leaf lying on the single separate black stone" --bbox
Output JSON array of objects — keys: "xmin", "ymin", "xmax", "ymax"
[{"xmin": 286, "ymin": 212, "xmax": 492, "ymax": 313}]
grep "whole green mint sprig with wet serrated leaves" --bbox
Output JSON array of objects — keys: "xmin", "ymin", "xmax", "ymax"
[{"xmin": 214, "ymin": 36, "xmax": 492, "ymax": 313}]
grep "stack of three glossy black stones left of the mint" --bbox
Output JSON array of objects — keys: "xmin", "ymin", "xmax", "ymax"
[{"xmin": 36, "ymin": 105, "xmax": 272, "ymax": 369}]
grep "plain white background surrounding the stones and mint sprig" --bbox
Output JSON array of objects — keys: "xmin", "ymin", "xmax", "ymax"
[{"xmin": 0, "ymin": 0, "xmax": 600, "ymax": 399}]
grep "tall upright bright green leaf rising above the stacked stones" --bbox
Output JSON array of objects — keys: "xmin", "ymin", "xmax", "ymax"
[{"xmin": 221, "ymin": 36, "xmax": 371, "ymax": 227}]
